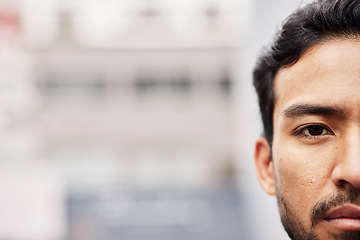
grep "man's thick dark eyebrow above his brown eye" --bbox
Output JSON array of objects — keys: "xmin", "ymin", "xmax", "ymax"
[{"xmin": 283, "ymin": 104, "xmax": 346, "ymax": 118}]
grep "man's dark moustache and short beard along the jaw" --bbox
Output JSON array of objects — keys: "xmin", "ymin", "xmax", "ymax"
[{"xmin": 277, "ymin": 188, "xmax": 360, "ymax": 240}]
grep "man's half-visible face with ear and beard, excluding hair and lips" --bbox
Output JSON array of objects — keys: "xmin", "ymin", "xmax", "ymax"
[{"xmin": 255, "ymin": 39, "xmax": 360, "ymax": 240}]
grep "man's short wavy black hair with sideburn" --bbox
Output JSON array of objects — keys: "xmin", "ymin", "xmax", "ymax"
[{"xmin": 253, "ymin": 0, "xmax": 360, "ymax": 145}]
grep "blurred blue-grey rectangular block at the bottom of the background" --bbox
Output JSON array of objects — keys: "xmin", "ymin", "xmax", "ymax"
[{"xmin": 69, "ymin": 189, "xmax": 247, "ymax": 240}]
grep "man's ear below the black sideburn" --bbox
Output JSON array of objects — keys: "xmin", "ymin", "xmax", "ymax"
[{"xmin": 254, "ymin": 137, "xmax": 276, "ymax": 195}]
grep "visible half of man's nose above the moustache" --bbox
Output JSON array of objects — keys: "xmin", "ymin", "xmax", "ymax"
[{"xmin": 331, "ymin": 129, "xmax": 360, "ymax": 189}]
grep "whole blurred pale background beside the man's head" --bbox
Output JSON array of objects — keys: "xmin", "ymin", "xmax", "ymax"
[{"xmin": 0, "ymin": 0, "xmax": 310, "ymax": 240}]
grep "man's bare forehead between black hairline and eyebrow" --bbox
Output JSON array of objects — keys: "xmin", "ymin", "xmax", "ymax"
[{"xmin": 274, "ymin": 39, "xmax": 360, "ymax": 121}]
